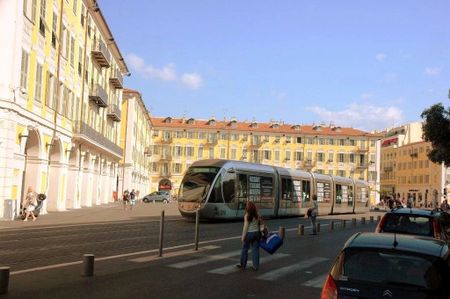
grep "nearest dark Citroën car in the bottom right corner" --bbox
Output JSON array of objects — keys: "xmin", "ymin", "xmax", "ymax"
[{"xmin": 321, "ymin": 233, "xmax": 450, "ymax": 299}]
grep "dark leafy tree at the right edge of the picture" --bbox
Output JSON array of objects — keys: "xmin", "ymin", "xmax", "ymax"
[{"xmin": 421, "ymin": 103, "xmax": 450, "ymax": 167}]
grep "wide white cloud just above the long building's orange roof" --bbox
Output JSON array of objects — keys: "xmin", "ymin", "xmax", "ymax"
[{"xmin": 306, "ymin": 103, "xmax": 403, "ymax": 131}]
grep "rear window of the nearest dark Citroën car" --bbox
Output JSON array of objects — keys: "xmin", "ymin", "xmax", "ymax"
[{"xmin": 339, "ymin": 250, "xmax": 449, "ymax": 289}]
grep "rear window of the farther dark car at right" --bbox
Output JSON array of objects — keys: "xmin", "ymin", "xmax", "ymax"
[{"xmin": 382, "ymin": 214, "xmax": 433, "ymax": 236}]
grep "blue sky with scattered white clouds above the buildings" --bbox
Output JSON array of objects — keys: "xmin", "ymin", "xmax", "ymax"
[{"xmin": 99, "ymin": 0, "xmax": 450, "ymax": 131}]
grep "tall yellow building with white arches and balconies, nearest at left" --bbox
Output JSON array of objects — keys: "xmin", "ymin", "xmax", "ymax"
[{"xmin": 0, "ymin": 0, "xmax": 128, "ymax": 218}]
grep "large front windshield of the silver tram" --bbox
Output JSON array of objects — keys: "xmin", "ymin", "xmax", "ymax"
[{"xmin": 178, "ymin": 167, "xmax": 220, "ymax": 202}]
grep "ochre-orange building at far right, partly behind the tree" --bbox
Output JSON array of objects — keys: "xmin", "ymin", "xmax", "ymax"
[{"xmin": 381, "ymin": 122, "xmax": 449, "ymax": 208}]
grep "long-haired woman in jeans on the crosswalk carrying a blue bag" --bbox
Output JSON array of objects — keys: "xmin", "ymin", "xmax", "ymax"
[{"xmin": 236, "ymin": 201, "xmax": 260, "ymax": 271}]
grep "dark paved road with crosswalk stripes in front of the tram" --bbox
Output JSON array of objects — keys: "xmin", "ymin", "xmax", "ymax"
[{"xmin": 0, "ymin": 203, "xmax": 382, "ymax": 298}]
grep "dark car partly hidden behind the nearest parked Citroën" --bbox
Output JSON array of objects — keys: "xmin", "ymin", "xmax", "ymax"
[{"xmin": 375, "ymin": 208, "xmax": 450, "ymax": 243}]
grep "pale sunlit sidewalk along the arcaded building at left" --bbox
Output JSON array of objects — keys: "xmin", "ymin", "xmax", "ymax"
[{"xmin": 0, "ymin": 202, "xmax": 180, "ymax": 232}]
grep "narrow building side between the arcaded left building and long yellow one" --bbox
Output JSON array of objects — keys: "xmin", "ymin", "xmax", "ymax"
[{"xmin": 119, "ymin": 89, "xmax": 151, "ymax": 197}]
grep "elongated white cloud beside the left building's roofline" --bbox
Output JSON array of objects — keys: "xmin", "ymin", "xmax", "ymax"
[{"xmin": 126, "ymin": 53, "xmax": 203, "ymax": 89}]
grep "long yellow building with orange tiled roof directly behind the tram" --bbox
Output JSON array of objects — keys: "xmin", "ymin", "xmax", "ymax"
[{"xmin": 151, "ymin": 117, "xmax": 379, "ymax": 203}]
